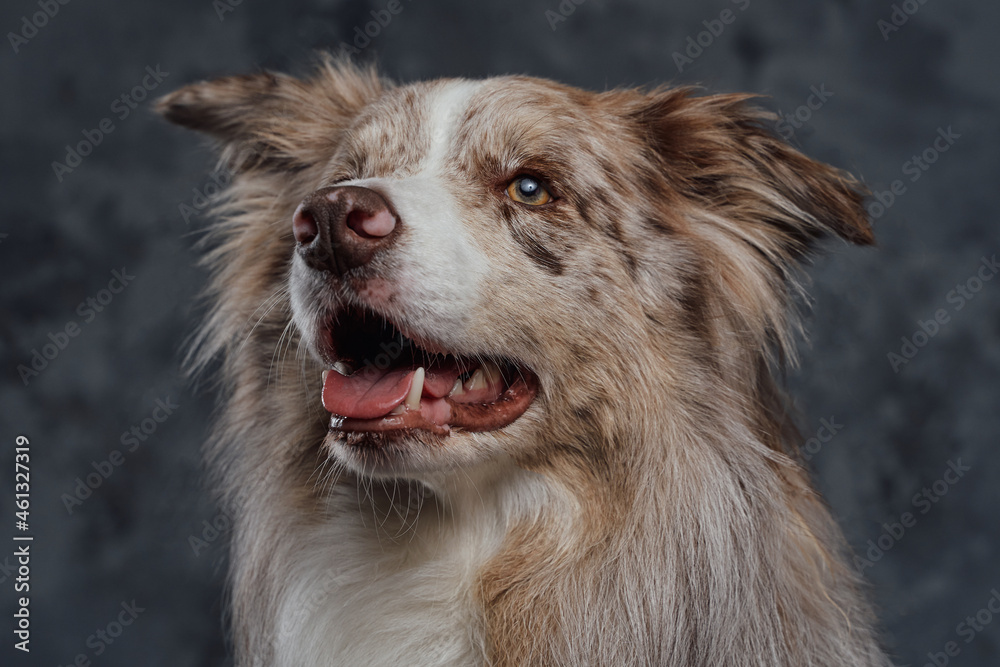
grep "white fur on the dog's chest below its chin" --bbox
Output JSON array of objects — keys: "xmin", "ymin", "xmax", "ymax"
[{"xmin": 274, "ymin": 464, "xmax": 544, "ymax": 667}]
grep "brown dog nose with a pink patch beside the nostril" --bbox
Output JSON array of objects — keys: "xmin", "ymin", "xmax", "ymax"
[{"xmin": 292, "ymin": 185, "xmax": 399, "ymax": 276}]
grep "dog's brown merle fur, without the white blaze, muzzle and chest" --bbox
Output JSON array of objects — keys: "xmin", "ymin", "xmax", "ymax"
[{"xmin": 159, "ymin": 54, "xmax": 889, "ymax": 666}]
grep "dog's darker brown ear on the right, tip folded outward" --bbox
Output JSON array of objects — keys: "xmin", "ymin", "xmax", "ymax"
[{"xmin": 630, "ymin": 88, "xmax": 875, "ymax": 258}]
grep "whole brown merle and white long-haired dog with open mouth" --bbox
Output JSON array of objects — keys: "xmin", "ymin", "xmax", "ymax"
[{"xmin": 158, "ymin": 57, "xmax": 890, "ymax": 667}]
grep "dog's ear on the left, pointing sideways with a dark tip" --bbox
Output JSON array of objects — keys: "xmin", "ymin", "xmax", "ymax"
[{"xmin": 156, "ymin": 58, "xmax": 383, "ymax": 169}]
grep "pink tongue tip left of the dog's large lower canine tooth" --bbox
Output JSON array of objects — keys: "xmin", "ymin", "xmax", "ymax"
[{"xmin": 323, "ymin": 366, "xmax": 415, "ymax": 419}]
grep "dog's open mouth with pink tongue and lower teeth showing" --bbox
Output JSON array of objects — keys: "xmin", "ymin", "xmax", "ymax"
[{"xmin": 322, "ymin": 309, "xmax": 538, "ymax": 435}]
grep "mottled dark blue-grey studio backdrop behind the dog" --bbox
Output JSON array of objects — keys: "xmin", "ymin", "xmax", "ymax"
[{"xmin": 0, "ymin": 0, "xmax": 1000, "ymax": 667}]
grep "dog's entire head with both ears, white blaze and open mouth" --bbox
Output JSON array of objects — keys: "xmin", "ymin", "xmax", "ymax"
[{"xmin": 160, "ymin": 62, "xmax": 872, "ymax": 476}]
